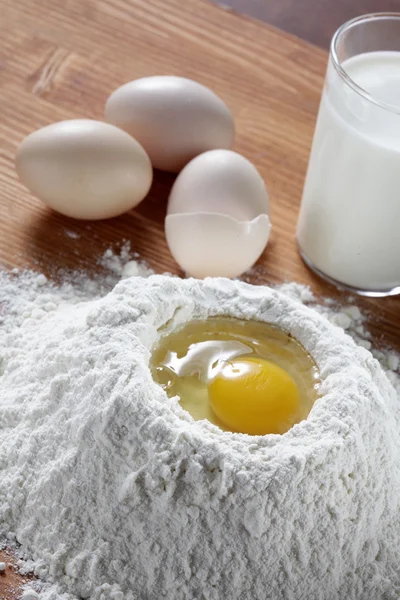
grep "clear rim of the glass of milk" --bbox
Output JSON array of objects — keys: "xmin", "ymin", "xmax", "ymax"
[{"xmin": 329, "ymin": 12, "xmax": 400, "ymax": 115}]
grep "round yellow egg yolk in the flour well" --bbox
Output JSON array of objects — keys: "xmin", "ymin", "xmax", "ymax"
[{"xmin": 208, "ymin": 357, "xmax": 300, "ymax": 435}]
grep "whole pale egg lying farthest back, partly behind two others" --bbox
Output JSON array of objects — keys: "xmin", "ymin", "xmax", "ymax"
[{"xmin": 105, "ymin": 76, "xmax": 235, "ymax": 172}]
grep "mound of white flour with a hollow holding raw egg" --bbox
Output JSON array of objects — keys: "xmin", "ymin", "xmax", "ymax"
[{"xmin": 0, "ymin": 255, "xmax": 400, "ymax": 600}]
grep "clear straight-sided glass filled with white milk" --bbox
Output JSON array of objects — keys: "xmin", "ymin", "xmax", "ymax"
[{"xmin": 297, "ymin": 13, "xmax": 400, "ymax": 296}]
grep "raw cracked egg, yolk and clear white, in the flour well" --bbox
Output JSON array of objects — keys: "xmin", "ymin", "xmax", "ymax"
[{"xmin": 151, "ymin": 317, "xmax": 319, "ymax": 435}]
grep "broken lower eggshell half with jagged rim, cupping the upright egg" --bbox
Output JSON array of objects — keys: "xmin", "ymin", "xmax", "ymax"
[{"xmin": 165, "ymin": 213, "xmax": 271, "ymax": 279}]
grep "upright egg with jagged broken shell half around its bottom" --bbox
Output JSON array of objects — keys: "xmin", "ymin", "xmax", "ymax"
[{"xmin": 165, "ymin": 150, "xmax": 271, "ymax": 278}]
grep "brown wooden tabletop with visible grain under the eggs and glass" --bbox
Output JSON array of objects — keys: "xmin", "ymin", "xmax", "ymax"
[{"xmin": 0, "ymin": 0, "xmax": 400, "ymax": 600}]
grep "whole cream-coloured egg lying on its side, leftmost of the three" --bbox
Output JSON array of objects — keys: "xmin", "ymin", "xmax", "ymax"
[{"xmin": 16, "ymin": 119, "xmax": 153, "ymax": 219}]
